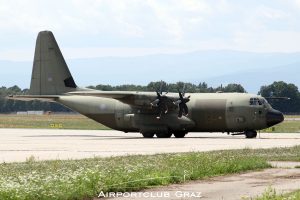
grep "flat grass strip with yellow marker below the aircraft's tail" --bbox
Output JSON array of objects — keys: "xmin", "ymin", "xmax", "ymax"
[{"xmin": 0, "ymin": 115, "xmax": 109, "ymax": 130}]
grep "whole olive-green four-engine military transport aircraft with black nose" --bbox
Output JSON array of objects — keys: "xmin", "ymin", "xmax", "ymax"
[{"xmin": 10, "ymin": 31, "xmax": 284, "ymax": 138}]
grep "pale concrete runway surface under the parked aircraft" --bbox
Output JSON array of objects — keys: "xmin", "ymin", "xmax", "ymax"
[{"xmin": 0, "ymin": 129, "xmax": 300, "ymax": 162}]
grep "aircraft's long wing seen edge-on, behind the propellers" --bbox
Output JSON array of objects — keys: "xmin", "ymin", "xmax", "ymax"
[{"xmin": 67, "ymin": 90, "xmax": 178, "ymax": 108}]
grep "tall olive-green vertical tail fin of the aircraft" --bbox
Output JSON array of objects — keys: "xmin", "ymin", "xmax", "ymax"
[{"xmin": 29, "ymin": 31, "xmax": 77, "ymax": 95}]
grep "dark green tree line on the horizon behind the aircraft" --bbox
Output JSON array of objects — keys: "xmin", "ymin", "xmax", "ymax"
[{"xmin": 0, "ymin": 81, "xmax": 300, "ymax": 113}]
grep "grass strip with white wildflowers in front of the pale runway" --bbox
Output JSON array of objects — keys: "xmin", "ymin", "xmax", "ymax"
[{"xmin": 0, "ymin": 150, "xmax": 270, "ymax": 200}]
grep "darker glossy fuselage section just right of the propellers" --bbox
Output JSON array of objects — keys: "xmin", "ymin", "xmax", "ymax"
[{"xmin": 192, "ymin": 99, "xmax": 227, "ymax": 132}]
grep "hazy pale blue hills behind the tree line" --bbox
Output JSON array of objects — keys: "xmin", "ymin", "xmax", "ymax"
[{"xmin": 0, "ymin": 50, "xmax": 300, "ymax": 93}]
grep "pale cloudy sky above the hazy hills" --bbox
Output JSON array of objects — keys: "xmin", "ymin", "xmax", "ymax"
[{"xmin": 0, "ymin": 0, "xmax": 300, "ymax": 60}]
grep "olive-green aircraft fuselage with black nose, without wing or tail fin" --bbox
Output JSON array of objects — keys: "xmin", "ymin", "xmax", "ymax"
[{"xmin": 58, "ymin": 93, "xmax": 283, "ymax": 132}]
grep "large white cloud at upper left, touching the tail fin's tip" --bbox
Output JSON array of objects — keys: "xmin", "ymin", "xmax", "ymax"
[{"xmin": 0, "ymin": 0, "xmax": 212, "ymax": 40}]
